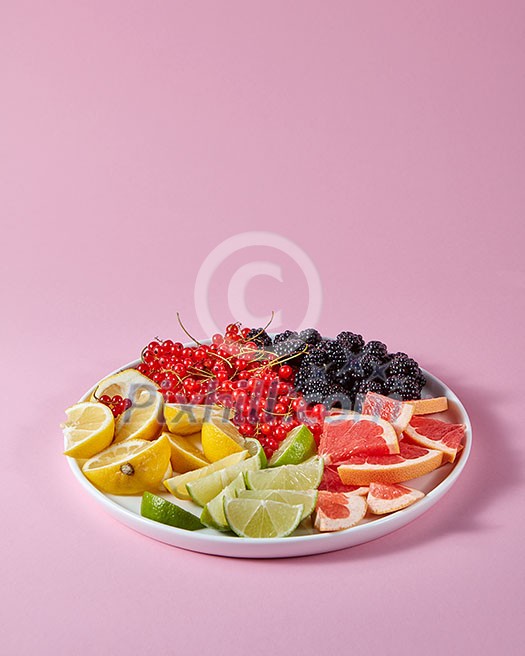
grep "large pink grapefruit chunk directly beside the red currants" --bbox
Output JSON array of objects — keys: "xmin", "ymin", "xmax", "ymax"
[{"xmin": 318, "ymin": 413, "xmax": 399, "ymax": 465}]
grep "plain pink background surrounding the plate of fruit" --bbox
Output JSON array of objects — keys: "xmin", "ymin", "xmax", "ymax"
[{"xmin": 0, "ymin": 0, "xmax": 525, "ymax": 655}]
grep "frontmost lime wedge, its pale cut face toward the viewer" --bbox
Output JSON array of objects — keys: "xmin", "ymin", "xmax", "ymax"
[{"xmin": 224, "ymin": 499, "xmax": 303, "ymax": 538}]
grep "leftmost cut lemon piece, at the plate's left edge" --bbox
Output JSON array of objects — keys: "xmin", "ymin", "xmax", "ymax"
[{"xmin": 62, "ymin": 402, "xmax": 115, "ymax": 458}]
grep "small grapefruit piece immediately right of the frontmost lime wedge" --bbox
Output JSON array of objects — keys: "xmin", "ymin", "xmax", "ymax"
[{"xmin": 314, "ymin": 490, "xmax": 366, "ymax": 533}]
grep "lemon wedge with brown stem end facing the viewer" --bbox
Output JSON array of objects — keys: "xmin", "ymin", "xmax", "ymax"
[{"xmin": 82, "ymin": 435, "xmax": 171, "ymax": 494}]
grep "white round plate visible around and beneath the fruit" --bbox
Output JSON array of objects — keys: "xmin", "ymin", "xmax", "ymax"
[{"xmin": 68, "ymin": 361, "xmax": 472, "ymax": 558}]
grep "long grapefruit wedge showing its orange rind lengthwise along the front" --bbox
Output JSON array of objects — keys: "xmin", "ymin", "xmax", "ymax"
[{"xmin": 337, "ymin": 440, "xmax": 443, "ymax": 485}]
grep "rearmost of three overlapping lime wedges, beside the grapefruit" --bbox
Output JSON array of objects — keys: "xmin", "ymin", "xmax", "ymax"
[{"xmin": 245, "ymin": 456, "xmax": 324, "ymax": 490}]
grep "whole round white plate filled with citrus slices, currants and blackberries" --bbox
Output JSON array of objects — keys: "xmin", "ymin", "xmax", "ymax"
[{"xmin": 62, "ymin": 322, "xmax": 472, "ymax": 558}]
